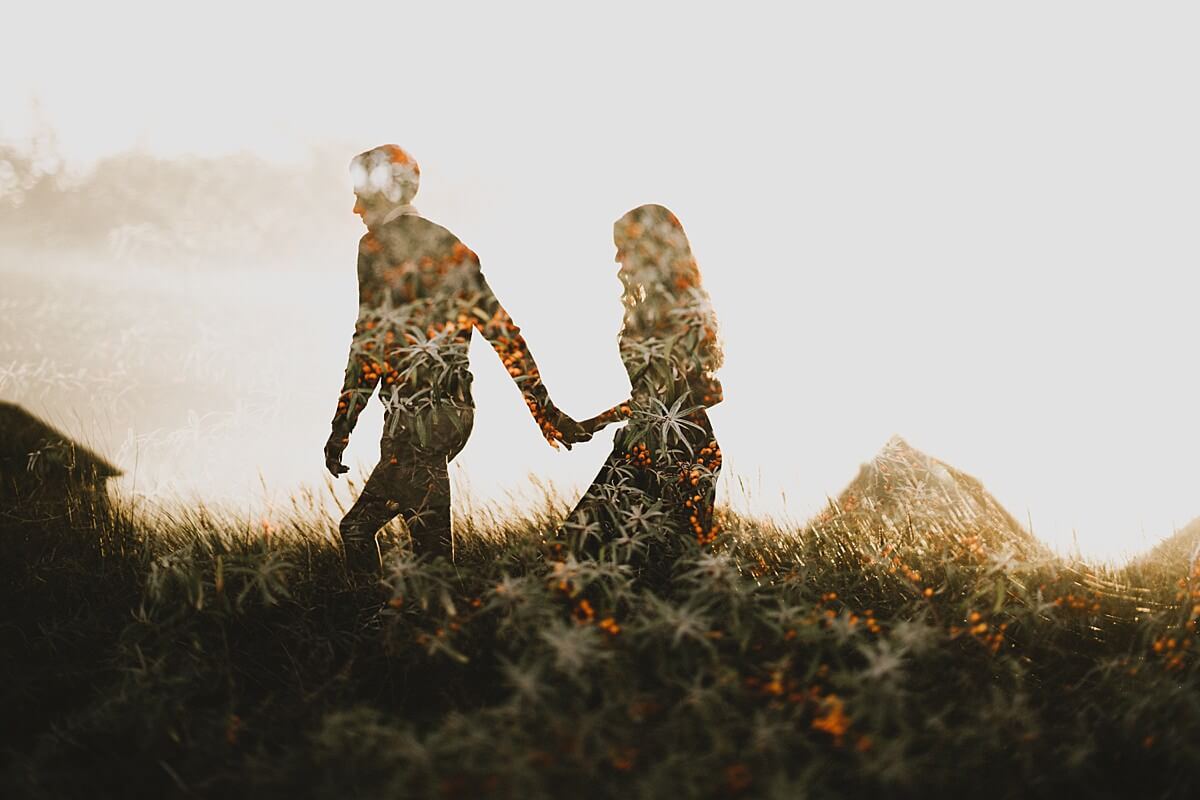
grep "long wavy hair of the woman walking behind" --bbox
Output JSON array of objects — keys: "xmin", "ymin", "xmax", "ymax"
[{"xmin": 613, "ymin": 204, "xmax": 725, "ymax": 388}]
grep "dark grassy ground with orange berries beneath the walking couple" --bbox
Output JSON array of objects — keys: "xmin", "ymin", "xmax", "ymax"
[{"xmin": 0, "ymin": 489, "xmax": 1200, "ymax": 799}]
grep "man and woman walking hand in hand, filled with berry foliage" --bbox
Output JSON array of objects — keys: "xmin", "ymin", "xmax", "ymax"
[{"xmin": 325, "ymin": 145, "xmax": 722, "ymax": 575}]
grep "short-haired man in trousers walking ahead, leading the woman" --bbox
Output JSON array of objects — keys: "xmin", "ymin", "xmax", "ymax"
[{"xmin": 325, "ymin": 145, "xmax": 590, "ymax": 575}]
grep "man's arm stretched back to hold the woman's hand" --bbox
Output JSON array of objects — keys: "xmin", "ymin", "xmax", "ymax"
[{"xmin": 473, "ymin": 271, "xmax": 592, "ymax": 450}]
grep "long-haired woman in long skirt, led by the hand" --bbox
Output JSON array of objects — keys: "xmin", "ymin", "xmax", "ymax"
[{"xmin": 560, "ymin": 205, "xmax": 722, "ymax": 563}]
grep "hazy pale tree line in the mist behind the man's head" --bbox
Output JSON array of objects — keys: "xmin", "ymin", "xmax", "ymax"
[{"xmin": 0, "ymin": 133, "xmax": 348, "ymax": 261}]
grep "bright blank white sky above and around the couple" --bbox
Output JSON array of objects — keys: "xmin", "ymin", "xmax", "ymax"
[{"xmin": 0, "ymin": 1, "xmax": 1200, "ymax": 557}]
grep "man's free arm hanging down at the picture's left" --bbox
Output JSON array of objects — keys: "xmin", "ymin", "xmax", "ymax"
[{"xmin": 325, "ymin": 248, "xmax": 384, "ymax": 477}]
